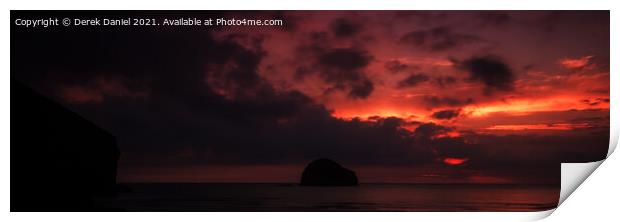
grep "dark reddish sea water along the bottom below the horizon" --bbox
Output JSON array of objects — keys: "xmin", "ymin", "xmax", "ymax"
[{"xmin": 95, "ymin": 183, "xmax": 559, "ymax": 211}]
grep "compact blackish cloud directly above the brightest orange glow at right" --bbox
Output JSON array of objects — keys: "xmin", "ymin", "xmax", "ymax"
[{"xmin": 458, "ymin": 55, "xmax": 515, "ymax": 94}]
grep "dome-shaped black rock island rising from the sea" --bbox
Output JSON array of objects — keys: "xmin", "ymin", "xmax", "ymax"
[{"xmin": 300, "ymin": 159, "xmax": 357, "ymax": 186}]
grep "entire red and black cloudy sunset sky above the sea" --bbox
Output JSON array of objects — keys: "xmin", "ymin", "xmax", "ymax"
[{"xmin": 11, "ymin": 11, "xmax": 610, "ymax": 184}]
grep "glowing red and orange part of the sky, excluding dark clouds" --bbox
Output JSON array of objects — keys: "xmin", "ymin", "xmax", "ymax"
[{"xmin": 216, "ymin": 12, "xmax": 609, "ymax": 133}]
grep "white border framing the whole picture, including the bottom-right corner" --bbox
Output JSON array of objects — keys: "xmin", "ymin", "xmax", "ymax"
[{"xmin": 0, "ymin": 0, "xmax": 619, "ymax": 222}]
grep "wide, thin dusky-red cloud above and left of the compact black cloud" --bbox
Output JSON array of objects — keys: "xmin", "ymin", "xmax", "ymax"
[{"xmin": 399, "ymin": 27, "xmax": 481, "ymax": 51}]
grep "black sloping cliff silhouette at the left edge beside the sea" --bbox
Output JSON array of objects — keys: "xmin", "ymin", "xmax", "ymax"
[{"xmin": 10, "ymin": 80, "xmax": 120, "ymax": 211}]
